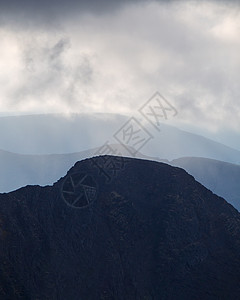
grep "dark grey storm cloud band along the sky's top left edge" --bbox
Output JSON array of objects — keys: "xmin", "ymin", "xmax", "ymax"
[{"xmin": 0, "ymin": 0, "xmax": 150, "ymax": 27}]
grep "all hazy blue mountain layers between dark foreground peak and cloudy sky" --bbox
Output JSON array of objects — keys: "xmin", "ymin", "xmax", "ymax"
[{"xmin": 0, "ymin": 114, "xmax": 240, "ymax": 210}]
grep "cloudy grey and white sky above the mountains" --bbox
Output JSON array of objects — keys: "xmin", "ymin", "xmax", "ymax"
[{"xmin": 0, "ymin": 0, "xmax": 240, "ymax": 149}]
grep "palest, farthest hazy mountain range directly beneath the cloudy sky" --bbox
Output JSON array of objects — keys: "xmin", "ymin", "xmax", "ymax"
[{"xmin": 0, "ymin": 114, "xmax": 240, "ymax": 164}]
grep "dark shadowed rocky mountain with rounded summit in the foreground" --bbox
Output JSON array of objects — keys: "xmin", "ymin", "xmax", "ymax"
[{"xmin": 0, "ymin": 156, "xmax": 240, "ymax": 300}]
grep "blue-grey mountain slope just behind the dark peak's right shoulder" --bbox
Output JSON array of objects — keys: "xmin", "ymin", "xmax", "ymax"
[{"xmin": 170, "ymin": 157, "xmax": 240, "ymax": 211}]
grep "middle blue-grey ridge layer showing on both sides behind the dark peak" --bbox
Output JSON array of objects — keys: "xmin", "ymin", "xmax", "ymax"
[{"xmin": 0, "ymin": 144, "xmax": 240, "ymax": 211}]
